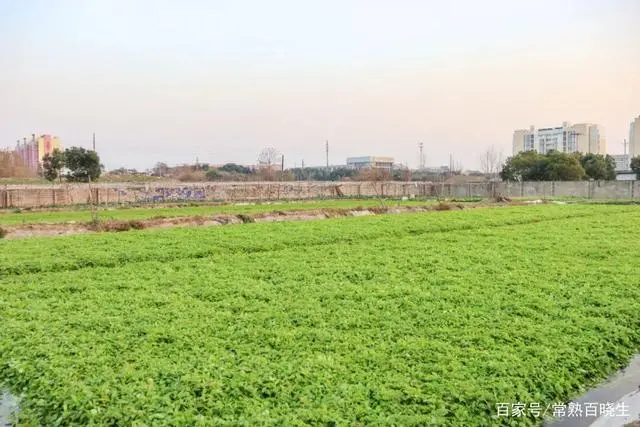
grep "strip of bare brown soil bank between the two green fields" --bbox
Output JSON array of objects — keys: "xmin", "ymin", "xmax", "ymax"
[{"xmin": 3, "ymin": 203, "xmax": 504, "ymax": 239}]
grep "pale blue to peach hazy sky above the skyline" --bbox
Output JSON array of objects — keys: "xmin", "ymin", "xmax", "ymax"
[{"xmin": 0, "ymin": 0, "xmax": 640, "ymax": 169}]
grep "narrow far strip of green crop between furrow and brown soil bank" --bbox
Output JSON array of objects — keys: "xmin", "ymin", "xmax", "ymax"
[{"xmin": 0, "ymin": 205, "xmax": 635, "ymax": 277}]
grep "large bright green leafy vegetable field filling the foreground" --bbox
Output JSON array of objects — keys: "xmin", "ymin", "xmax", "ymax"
[{"xmin": 0, "ymin": 205, "xmax": 640, "ymax": 426}]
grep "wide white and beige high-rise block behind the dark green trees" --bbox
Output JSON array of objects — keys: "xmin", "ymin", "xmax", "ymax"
[{"xmin": 513, "ymin": 122, "xmax": 608, "ymax": 154}]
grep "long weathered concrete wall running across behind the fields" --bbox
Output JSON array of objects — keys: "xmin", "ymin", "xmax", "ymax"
[{"xmin": 0, "ymin": 181, "xmax": 640, "ymax": 208}]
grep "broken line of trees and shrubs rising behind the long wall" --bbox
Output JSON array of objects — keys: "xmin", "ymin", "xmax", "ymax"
[{"xmin": 40, "ymin": 147, "xmax": 640, "ymax": 182}]
